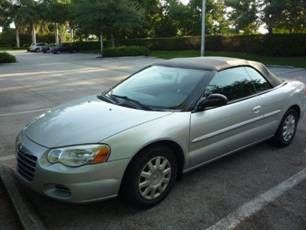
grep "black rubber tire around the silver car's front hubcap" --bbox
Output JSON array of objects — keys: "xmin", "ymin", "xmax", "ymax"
[{"xmin": 120, "ymin": 145, "xmax": 178, "ymax": 208}]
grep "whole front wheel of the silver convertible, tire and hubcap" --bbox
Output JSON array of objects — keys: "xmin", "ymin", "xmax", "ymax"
[{"xmin": 121, "ymin": 146, "xmax": 177, "ymax": 208}]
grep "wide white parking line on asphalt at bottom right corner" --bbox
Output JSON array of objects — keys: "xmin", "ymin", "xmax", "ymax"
[{"xmin": 207, "ymin": 168, "xmax": 306, "ymax": 230}]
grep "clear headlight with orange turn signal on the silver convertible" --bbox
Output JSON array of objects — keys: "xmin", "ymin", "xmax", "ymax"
[{"xmin": 47, "ymin": 145, "xmax": 111, "ymax": 167}]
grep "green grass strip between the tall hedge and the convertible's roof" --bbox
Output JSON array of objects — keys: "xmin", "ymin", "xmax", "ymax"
[{"xmin": 150, "ymin": 50, "xmax": 306, "ymax": 68}]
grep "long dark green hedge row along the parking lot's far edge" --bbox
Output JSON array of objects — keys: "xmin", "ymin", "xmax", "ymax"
[{"xmin": 71, "ymin": 34, "xmax": 306, "ymax": 56}]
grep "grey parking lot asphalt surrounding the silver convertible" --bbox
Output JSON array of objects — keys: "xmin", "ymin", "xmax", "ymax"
[{"xmin": 0, "ymin": 51, "xmax": 306, "ymax": 229}]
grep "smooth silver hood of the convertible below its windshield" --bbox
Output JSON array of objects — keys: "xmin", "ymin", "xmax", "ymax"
[{"xmin": 24, "ymin": 96, "xmax": 171, "ymax": 148}]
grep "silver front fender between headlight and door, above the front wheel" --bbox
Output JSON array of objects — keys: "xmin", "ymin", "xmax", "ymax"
[{"xmin": 101, "ymin": 112, "xmax": 191, "ymax": 170}]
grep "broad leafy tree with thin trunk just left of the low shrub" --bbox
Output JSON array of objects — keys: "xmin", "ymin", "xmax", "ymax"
[{"xmin": 72, "ymin": 0, "xmax": 143, "ymax": 55}]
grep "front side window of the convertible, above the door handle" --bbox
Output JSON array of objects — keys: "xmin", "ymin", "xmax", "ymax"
[{"xmin": 205, "ymin": 67, "xmax": 256, "ymax": 101}]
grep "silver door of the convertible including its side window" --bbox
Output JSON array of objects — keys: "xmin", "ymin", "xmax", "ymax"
[{"xmin": 189, "ymin": 67, "xmax": 264, "ymax": 166}]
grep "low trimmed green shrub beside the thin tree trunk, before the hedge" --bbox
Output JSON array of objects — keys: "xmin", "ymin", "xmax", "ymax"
[{"xmin": 103, "ymin": 46, "xmax": 149, "ymax": 57}]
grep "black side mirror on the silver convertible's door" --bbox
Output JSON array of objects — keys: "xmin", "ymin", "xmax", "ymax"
[{"xmin": 197, "ymin": 93, "xmax": 228, "ymax": 111}]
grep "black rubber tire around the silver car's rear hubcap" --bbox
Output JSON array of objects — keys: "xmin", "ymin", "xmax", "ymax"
[{"xmin": 272, "ymin": 108, "xmax": 299, "ymax": 147}]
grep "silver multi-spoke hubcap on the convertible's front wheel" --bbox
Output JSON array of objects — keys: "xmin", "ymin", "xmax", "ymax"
[{"xmin": 138, "ymin": 156, "xmax": 171, "ymax": 200}]
